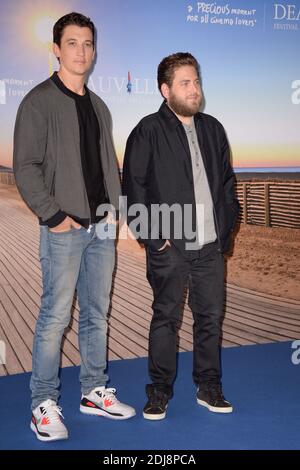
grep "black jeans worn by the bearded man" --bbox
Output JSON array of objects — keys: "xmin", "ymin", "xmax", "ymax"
[{"xmin": 147, "ymin": 242, "xmax": 224, "ymax": 396}]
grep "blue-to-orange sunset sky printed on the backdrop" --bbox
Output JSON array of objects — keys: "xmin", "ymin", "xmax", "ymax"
[{"xmin": 0, "ymin": 0, "xmax": 300, "ymax": 171}]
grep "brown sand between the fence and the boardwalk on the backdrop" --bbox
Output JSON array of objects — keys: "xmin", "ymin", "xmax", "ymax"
[{"xmin": 119, "ymin": 225, "xmax": 300, "ymax": 300}]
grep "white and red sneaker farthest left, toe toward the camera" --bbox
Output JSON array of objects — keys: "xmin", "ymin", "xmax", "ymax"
[{"xmin": 30, "ymin": 399, "xmax": 68, "ymax": 441}]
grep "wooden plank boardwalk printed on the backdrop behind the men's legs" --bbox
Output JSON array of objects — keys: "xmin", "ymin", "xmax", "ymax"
[{"xmin": 0, "ymin": 184, "xmax": 300, "ymax": 375}]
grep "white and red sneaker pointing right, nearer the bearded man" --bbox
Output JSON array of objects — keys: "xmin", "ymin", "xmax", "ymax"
[{"xmin": 80, "ymin": 387, "xmax": 135, "ymax": 419}]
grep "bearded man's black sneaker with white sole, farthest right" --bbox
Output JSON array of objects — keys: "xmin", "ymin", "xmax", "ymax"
[{"xmin": 197, "ymin": 384, "xmax": 233, "ymax": 413}]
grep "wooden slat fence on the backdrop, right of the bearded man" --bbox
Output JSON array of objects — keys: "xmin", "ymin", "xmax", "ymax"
[{"xmin": 237, "ymin": 181, "xmax": 300, "ymax": 229}]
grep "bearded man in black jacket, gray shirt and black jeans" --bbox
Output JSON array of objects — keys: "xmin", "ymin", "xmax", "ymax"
[{"xmin": 123, "ymin": 52, "xmax": 239, "ymax": 420}]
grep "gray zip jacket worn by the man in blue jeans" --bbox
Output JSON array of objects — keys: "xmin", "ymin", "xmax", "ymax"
[{"xmin": 13, "ymin": 79, "xmax": 121, "ymax": 221}]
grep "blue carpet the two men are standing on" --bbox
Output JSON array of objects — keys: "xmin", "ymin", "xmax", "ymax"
[{"xmin": 0, "ymin": 342, "xmax": 300, "ymax": 450}]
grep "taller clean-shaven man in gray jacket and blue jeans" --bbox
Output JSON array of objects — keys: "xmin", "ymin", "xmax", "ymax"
[{"xmin": 14, "ymin": 13, "xmax": 135, "ymax": 441}]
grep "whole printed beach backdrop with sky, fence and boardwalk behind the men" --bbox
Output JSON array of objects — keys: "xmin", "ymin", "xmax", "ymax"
[{"xmin": 0, "ymin": 0, "xmax": 300, "ymax": 375}]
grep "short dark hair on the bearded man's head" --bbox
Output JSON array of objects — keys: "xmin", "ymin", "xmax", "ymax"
[{"xmin": 157, "ymin": 52, "xmax": 200, "ymax": 92}]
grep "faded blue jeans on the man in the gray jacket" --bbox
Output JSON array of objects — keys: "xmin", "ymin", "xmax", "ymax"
[{"xmin": 30, "ymin": 224, "xmax": 115, "ymax": 409}]
